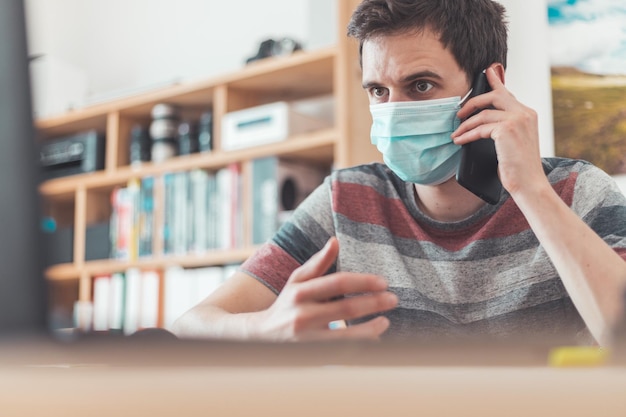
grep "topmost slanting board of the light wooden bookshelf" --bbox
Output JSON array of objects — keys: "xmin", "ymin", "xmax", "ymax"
[{"xmin": 36, "ymin": 47, "xmax": 337, "ymax": 138}]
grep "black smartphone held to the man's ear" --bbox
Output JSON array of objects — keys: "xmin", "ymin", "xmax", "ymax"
[{"xmin": 456, "ymin": 71, "xmax": 502, "ymax": 204}]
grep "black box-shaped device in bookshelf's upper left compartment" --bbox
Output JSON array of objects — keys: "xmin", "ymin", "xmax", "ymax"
[{"xmin": 39, "ymin": 130, "xmax": 105, "ymax": 179}]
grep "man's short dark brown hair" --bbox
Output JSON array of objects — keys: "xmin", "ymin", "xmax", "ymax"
[{"xmin": 348, "ymin": 0, "xmax": 507, "ymax": 80}]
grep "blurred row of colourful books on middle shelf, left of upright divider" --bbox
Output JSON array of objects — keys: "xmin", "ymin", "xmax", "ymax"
[{"xmin": 110, "ymin": 164, "xmax": 243, "ymax": 260}]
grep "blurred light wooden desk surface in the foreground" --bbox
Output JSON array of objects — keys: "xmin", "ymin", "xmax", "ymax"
[{"xmin": 0, "ymin": 336, "xmax": 626, "ymax": 417}]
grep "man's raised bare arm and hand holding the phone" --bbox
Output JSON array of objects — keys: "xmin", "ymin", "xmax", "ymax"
[{"xmin": 453, "ymin": 64, "xmax": 626, "ymax": 345}]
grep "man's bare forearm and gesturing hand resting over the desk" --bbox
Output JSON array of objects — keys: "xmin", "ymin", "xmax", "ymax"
[{"xmin": 172, "ymin": 238, "xmax": 398, "ymax": 341}]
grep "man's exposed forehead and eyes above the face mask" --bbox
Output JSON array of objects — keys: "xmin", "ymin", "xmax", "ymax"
[{"xmin": 362, "ymin": 30, "xmax": 470, "ymax": 104}]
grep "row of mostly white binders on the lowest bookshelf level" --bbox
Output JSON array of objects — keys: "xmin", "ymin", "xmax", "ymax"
[{"xmin": 89, "ymin": 264, "xmax": 239, "ymax": 335}]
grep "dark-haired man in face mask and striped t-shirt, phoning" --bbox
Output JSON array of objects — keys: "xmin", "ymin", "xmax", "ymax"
[{"xmin": 175, "ymin": 0, "xmax": 626, "ymax": 344}]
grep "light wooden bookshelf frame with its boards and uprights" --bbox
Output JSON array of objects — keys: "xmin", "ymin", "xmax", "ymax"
[{"xmin": 36, "ymin": 0, "xmax": 380, "ymax": 332}]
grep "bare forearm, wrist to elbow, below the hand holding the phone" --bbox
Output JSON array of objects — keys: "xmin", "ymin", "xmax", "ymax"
[{"xmin": 515, "ymin": 176, "xmax": 626, "ymax": 345}]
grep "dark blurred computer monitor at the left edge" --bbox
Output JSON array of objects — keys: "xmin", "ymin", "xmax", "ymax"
[{"xmin": 0, "ymin": 0, "xmax": 47, "ymax": 338}]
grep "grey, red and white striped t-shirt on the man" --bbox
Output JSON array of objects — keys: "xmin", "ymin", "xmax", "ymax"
[{"xmin": 242, "ymin": 158, "xmax": 626, "ymax": 338}]
